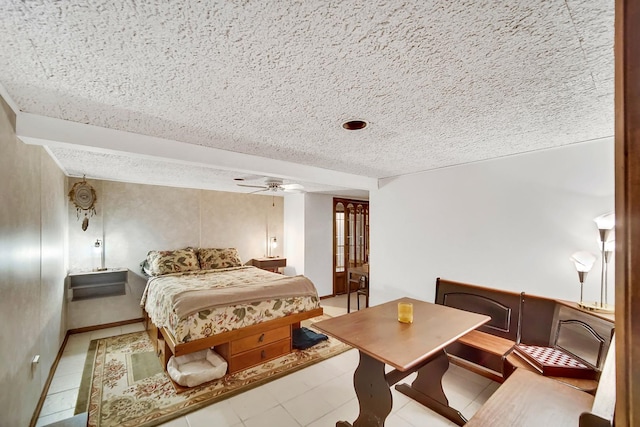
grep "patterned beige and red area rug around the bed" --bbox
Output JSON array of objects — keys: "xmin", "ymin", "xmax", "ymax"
[{"xmin": 75, "ymin": 315, "xmax": 350, "ymax": 427}]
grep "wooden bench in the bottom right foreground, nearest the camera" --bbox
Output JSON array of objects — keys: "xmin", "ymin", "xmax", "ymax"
[{"xmin": 465, "ymin": 340, "xmax": 615, "ymax": 427}]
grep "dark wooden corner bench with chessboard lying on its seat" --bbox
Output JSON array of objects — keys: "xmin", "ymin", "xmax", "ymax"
[{"xmin": 435, "ymin": 278, "xmax": 614, "ymax": 393}]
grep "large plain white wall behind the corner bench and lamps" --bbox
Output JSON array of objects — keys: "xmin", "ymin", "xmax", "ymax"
[{"xmin": 370, "ymin": 139, "xmax": 615, "ymax": 304}]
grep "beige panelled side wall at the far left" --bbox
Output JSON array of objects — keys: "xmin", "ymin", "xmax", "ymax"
[{"xmin": 0, "ymin": 99, "xmax": 67, "ymax": 426}]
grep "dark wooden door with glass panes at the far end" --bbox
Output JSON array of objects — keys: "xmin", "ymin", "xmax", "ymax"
[{"xmin": 333, "ymin": 198, "xmax": 369, "ymax": 295}]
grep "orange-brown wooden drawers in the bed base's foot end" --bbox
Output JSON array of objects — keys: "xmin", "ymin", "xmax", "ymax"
[{"xmin": 215, "ymin": 325, "xmax": 291, "ymax": 373}]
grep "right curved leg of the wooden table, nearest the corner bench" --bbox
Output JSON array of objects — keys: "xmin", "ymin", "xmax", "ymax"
[{"xmin": 396, "ymin": 350, "xmax": 467, "ymax": 426}]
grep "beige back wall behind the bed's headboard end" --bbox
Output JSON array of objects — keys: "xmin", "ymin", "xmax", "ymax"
[{"xmin": 67, "ymin": 178, "xmax": 283, "ymax": 329}]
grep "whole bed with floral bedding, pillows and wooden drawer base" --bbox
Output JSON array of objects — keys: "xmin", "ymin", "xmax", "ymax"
[{"xmin": 141, "ymin": 248, "xmax": 322, "ymax": 373}]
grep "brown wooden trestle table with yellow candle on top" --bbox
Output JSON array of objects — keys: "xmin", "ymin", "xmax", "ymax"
[{"xmin": 314, "ymin": 298, "xmax": 490, "ymax": 427}]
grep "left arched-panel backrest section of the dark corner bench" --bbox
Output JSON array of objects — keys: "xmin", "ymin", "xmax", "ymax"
[{"xmin": 435, "ymin": 277, "xmax": 520, "ymax": 341}]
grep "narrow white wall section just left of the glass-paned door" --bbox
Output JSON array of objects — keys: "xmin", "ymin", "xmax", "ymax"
[{"xmin": 304, "ymin": 193, "xmax": 333, "ymax": 296}]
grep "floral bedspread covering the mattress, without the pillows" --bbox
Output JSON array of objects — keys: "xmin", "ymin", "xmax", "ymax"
[{"xmin": 140, "ymin": 266, "xmax": 320, "ymax": 342}]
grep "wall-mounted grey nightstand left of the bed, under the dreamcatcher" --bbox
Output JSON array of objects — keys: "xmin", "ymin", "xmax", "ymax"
[{"xmin": 68, "ymin": 268, "xmax": 129, "ymax": 301}]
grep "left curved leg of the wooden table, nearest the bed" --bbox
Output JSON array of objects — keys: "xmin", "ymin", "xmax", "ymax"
[{"xmin": 336, "ymin": 352, "xmax": 393, "ymax": 427}]
